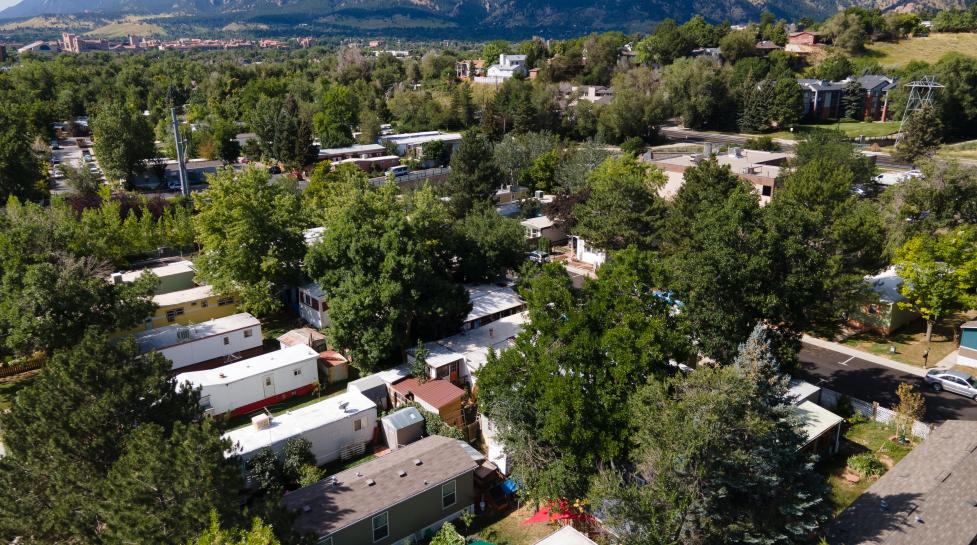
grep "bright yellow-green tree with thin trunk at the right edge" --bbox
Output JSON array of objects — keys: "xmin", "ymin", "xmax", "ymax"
[{"xmin": 894, "ymin": 227, "xmax": 977, "ymax": 348}]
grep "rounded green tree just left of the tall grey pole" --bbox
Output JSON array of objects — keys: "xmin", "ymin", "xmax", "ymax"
[{"xmin": 91, "ymin": 102, "xmax": 156, "ymax": 180}]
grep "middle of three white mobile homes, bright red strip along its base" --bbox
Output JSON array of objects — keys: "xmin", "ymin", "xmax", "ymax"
[{"xmin": 176, "ymin": 345, "xmax": 319, "ymax": 416}]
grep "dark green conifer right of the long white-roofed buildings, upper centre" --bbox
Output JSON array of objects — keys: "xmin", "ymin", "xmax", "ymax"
[{"xmin": 446, "ymin": 131, "xmax": 500, "ymax": 217}]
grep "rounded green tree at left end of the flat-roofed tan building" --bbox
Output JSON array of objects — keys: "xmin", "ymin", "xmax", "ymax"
[{"xmin": 573, "ymin": 155, "xmax": 666, "ymax": 251}]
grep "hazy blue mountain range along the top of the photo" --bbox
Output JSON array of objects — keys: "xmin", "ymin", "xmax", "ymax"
[{"xmin": 0, "ymin": 0, "xmax": 954, "ymax": 37}]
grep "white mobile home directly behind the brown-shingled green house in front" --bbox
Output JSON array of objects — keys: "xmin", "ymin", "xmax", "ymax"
[{"xmin": 224, "ymin": 392, "xmax": 377, "ymax": 465}]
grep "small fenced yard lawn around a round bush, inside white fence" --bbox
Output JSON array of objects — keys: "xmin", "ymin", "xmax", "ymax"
[{"xmin": 818, "ymin": 421, "xmax": 912, "ymax": 514}]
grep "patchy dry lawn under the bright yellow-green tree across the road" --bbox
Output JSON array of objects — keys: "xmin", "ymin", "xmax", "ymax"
[{"xmin": 843, "ymin": 311, "xmax": 977, "ymax": 367}]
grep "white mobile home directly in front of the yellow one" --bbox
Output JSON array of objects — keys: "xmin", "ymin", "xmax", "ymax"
[{"xmin": 135, "ymin": 312, "xmax": 262, "ymax": 371}]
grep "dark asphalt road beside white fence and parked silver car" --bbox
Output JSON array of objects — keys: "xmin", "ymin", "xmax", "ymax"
[{"xmin": 796, "ymin": 344, "xmax": 977, "ymax": 422}]
